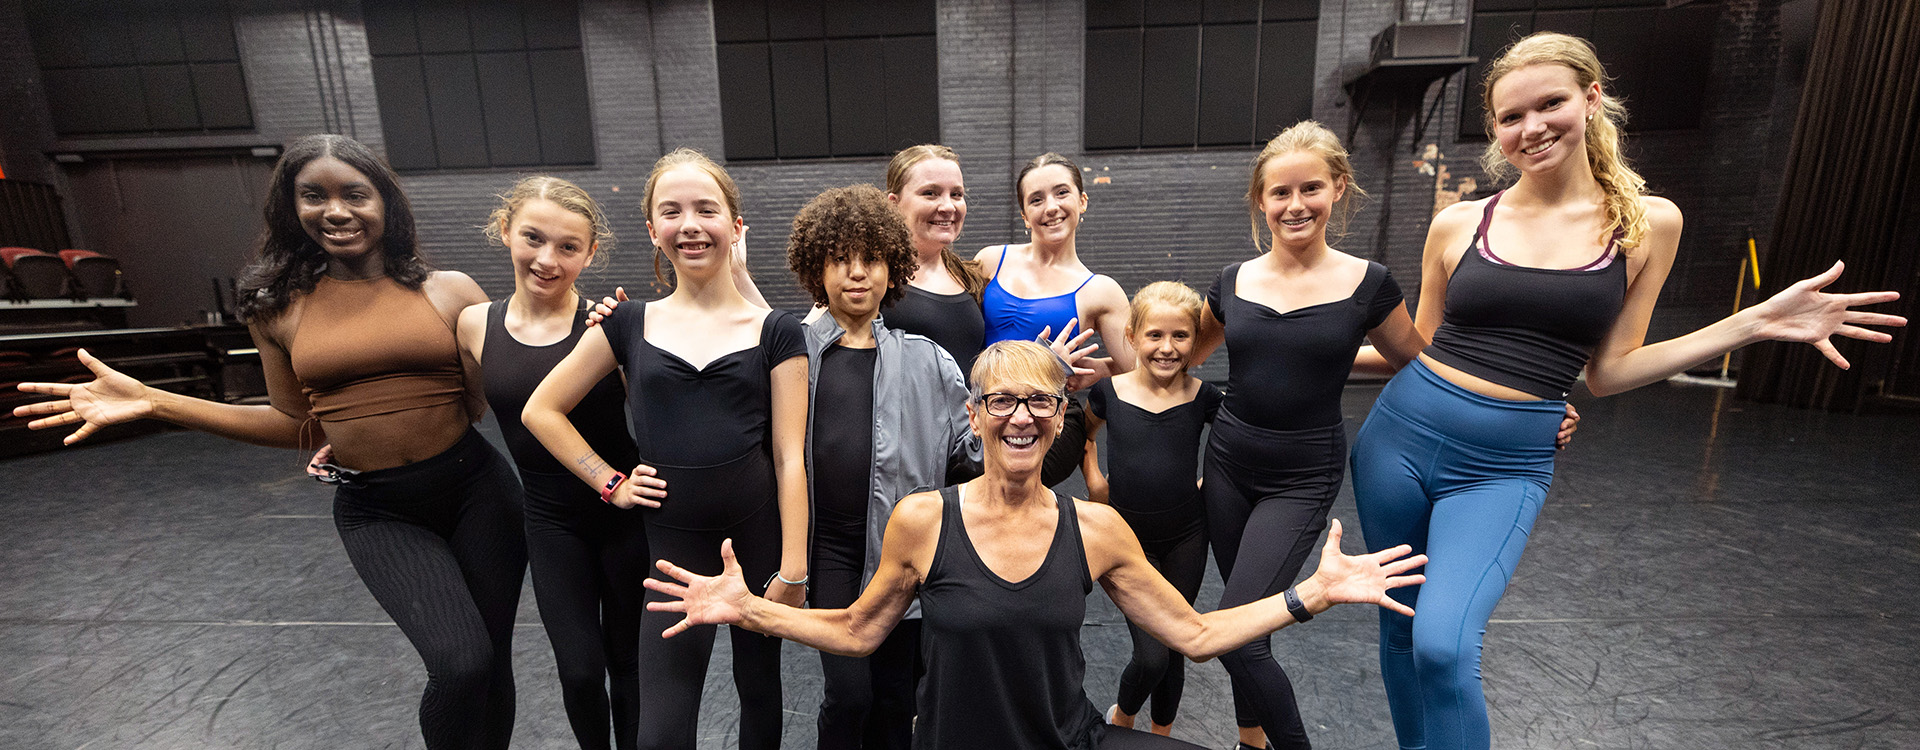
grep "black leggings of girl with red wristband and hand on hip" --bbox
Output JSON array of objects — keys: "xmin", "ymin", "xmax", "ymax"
[{"xmin": 637, "ymin": 449, "xmax": 783, "ymax": 750}]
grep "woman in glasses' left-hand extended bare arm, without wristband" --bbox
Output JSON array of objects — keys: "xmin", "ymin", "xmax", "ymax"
[{"xmin": 645, "ymin": 493, "xmax": 941, "ymax": 656}]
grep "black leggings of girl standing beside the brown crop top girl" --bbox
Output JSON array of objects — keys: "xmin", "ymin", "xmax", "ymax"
[{"xmin": 520, "ymin": 470, "xmax": 653, "ymax": 750}]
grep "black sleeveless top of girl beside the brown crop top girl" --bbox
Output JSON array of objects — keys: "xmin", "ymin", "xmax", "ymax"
[{"xmin": 480, "ymin": 299, "xmax": 639, "ymax": 474}]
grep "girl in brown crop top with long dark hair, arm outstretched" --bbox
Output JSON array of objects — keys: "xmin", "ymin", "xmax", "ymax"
[{"xmin": 17, "ymin": 136, "xmax": 526, "ymax": 748}]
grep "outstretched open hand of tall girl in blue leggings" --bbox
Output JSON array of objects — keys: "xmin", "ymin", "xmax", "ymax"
[{"xmin": 1751, "ymin": 261, "xmax": 1907, "ymax": 370}]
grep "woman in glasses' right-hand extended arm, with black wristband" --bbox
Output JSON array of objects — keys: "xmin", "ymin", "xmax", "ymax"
[{"xmin": 1081, "ymin": 506, "xmax": 1427, "ymax": 662}]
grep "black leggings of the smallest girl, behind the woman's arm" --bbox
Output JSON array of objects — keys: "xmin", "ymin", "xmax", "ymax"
[{"xmin": 1116, "ymin": 518, "xmax": 1206, "ymax": 725}]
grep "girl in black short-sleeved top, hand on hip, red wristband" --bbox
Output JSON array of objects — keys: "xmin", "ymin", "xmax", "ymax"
[{"xmin": 524, "ymin": 150, "xmax": 806, "ymax": 748}]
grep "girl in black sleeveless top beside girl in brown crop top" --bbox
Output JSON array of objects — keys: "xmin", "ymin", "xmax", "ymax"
[{"xmin": 459, "ymin": 176, "xmax": 664, "ymax": 748}]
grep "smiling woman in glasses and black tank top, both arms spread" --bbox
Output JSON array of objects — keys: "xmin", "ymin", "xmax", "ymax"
[{"xmin": 647, "ymin": 341, "xmax": 1425, "ymax": 750}]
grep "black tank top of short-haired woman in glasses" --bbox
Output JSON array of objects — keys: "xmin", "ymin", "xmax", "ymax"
[{"xmin": 914, "ymin": 487, "xmax": 1104, "ymax": 750}]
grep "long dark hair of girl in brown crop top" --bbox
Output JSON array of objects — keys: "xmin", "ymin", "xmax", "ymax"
[{"xmin": 238, "ymin": 134, "xmax": 432, "ymax": 322}]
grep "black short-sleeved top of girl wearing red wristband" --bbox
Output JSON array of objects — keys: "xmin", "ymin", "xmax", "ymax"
[{"xmin": 601, "ymin": 303, "xmax": 806, "ymax": 466}]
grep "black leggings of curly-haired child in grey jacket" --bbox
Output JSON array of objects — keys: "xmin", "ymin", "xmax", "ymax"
[{"xmin": 808, "ymin": 531, "xmax": 920, "ymax": 750}]
